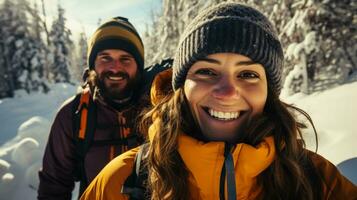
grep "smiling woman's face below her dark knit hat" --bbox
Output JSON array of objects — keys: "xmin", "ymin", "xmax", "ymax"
[{"xmin": 184, "ymin": 53, "xmax": 268, "ymax": 142}]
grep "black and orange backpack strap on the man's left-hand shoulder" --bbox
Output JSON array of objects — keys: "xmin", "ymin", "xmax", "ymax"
[{"xmin": 73, "ymin": 88, "xmax": 97, "ymax": 195}]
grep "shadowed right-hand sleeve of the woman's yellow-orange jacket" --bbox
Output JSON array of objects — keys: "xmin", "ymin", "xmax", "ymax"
[{"xmin": 312, "ymin": 154, "xmax": 357, "ymax": 200}]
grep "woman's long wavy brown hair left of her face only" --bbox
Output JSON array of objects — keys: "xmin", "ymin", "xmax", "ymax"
[{"xmin": 140, "ymin": 90, "xmax": 189, "ymax": 199}]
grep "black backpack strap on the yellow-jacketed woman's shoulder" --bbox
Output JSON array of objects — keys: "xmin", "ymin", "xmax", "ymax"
[{"xmin": 121, "ymin": 143, "xmax": 150, "ymax": 200}]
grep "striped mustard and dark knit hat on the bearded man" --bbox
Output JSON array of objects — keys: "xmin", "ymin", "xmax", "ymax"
[{"xmin": 87, "ymin": 17, "xmax": 144, "ymax": 71}]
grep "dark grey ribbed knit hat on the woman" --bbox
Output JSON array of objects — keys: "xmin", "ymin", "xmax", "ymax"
[{"xmin": 172, "ymin": 3, "xmax": 283, "ymax": 94}]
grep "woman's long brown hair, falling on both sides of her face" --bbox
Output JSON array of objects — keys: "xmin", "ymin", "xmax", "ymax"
[{"xmin": 141, "ymin": 87, "xmax": 322, "ymax": 200}]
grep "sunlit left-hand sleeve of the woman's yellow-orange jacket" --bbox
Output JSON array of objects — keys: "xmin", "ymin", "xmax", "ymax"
[{"xmin": 80, "ymin": 147, "xmax": 139, "ymax": 200}]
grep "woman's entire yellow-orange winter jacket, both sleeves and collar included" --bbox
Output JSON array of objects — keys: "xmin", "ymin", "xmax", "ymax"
[{"xmin": 81, "ymin": 68, "xmax": 357, "ymax": 200}]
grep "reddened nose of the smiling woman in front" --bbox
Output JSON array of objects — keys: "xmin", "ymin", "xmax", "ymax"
[{"xmin": 212, "ymin": 77, "xmax": 240, "ymax": 99}]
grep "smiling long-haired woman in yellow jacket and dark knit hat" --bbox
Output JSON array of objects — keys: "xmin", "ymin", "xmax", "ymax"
[{"xmin": 82, "ymin": 3, "xmax": 357, "ymax": 200}]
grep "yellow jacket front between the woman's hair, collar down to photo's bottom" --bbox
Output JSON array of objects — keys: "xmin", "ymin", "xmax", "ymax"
[{"xmin": 178, "ymin": 133, "xmax": 275, "ymax": 199}]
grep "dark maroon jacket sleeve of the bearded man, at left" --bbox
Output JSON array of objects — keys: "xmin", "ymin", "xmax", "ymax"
[{"xmin": 38, "ymin": 99, "xmax": 75, "ymax": 200}]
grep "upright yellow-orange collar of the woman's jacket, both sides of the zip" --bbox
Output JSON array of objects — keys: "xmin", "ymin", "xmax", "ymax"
[{"xmin": 178, "ymin": 133, "xmax": 275, "ymax": 178}]
